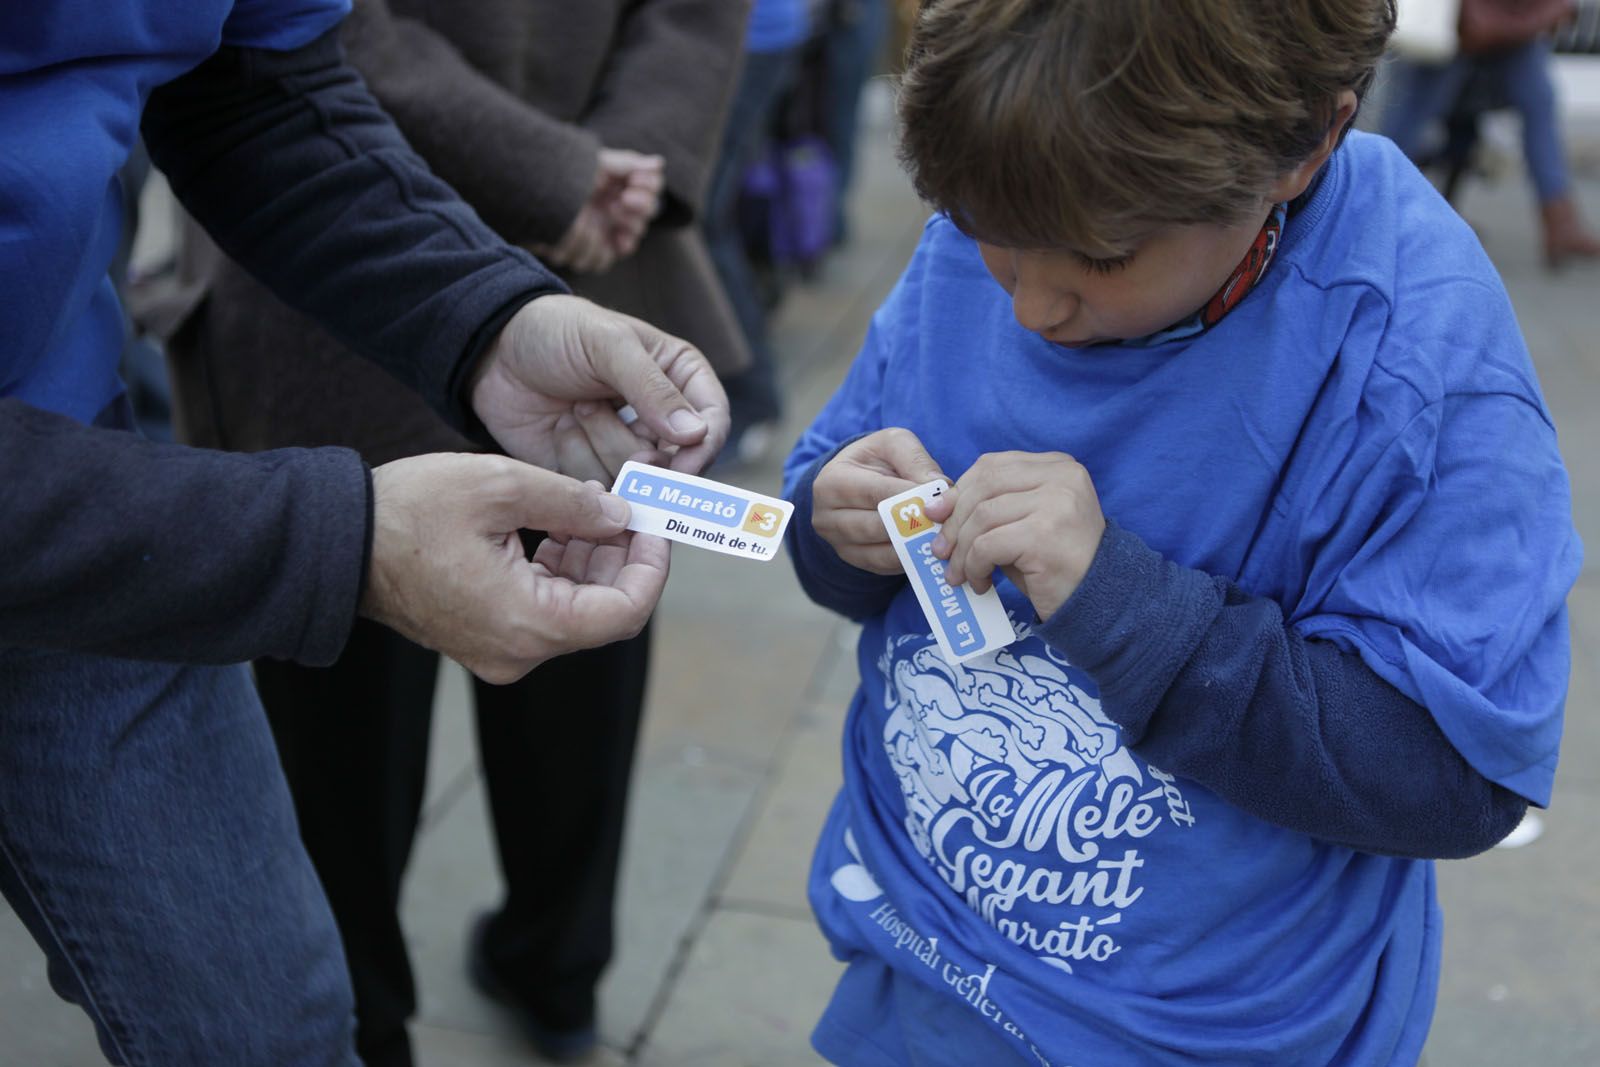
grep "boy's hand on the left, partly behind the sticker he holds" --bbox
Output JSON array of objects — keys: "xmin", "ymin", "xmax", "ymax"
[{"xmin": 811, "ymin": 427, "xmax": 944, "ymax": 574}]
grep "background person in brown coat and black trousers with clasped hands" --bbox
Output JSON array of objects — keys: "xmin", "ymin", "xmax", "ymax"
[{"xmin": 149, "ymin": 0, "xmax": 749, "ymax": 1067}]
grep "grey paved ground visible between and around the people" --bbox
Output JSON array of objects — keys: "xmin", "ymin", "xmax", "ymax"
[{"xmin": 0, "ymin": 75, "xmax": 1600, "ymax": 1067}]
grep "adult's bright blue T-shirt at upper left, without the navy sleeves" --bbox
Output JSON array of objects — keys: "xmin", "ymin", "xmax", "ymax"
[{"xmin": 0, "ymin": 0, "xmax": 350, "ymax": 422}]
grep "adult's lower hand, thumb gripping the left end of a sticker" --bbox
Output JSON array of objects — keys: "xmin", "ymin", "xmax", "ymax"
[{"xmin": 360, "ymin": 454, "xmax": 669, "ymax": 683}]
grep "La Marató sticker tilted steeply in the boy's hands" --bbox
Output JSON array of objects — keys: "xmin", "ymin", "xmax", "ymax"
[{"xmin": 878, "ymin": 482, "xmax": 1016, "ymax": 662}]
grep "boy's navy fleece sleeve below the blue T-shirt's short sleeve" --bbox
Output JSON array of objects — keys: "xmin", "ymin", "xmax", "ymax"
[{"xmin": 1038, "ymin": 523, "xmax": 1528, "ymax": 859}]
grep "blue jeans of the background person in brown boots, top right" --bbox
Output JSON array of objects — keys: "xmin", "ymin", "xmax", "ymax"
[{"xmin": 1382, "ymin": 38, "xmax": 1568, "ymax": 203}]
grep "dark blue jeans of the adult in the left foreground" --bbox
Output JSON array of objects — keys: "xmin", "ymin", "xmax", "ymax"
[{"xmin": 0, "ymin": 648, "xmax": 360, "ymax": 1067}]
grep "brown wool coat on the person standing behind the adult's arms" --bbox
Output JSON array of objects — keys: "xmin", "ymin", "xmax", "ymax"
[{"xmin": 159, "ymin": 0, "xmax": 749, "ymax": 464}]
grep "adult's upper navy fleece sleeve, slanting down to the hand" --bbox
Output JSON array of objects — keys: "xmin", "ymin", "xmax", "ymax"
[{"xmin": 144, "ymin": 32, "xmax": 565, "ymax": 435}]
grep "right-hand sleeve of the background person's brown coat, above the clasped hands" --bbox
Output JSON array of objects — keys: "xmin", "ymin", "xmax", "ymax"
[{"xmin": 584, "ymin": 0, "xmax": 750, "ymax": 226}]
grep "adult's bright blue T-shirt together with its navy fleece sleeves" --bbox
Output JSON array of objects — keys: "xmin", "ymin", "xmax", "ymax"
[{"xmin": 0, "ymin": 0, "xmax": 562, "ymax": 662}]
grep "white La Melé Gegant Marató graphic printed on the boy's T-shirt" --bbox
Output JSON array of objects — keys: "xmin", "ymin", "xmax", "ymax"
[{"xmin": 864, "ymin": 633, "xmax": 1194, "ymax": 973}]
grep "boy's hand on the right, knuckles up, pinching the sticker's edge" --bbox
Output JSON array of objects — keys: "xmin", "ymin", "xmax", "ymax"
[{"xmin": 928, "ymin": 453, "xmax": 1106, "ymax": 619}]
